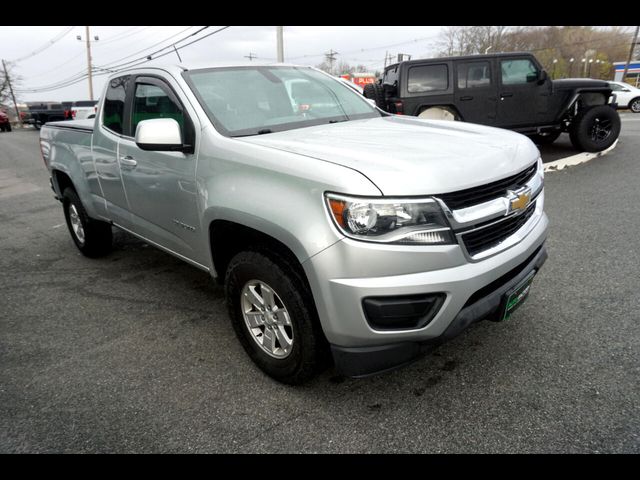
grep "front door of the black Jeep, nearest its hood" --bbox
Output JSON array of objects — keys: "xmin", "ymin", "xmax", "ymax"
[{"xmin": 496, "ymin": 57, "xmax": 551, "ymax": 128}]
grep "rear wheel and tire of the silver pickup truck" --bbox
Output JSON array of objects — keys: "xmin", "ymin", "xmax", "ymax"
[{"xmin": 62, "ymin": 188, "xmax": 113, "ymax": 258}]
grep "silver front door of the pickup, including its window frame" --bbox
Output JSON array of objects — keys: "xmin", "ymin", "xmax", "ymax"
[{"xmin": 119, "ymin": 75, "xmax": 205, "ymax": 263}]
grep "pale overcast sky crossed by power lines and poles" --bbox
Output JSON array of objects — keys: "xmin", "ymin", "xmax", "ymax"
[{"xmin": 0, "ymin": 26, "xmax": 443, "ymax": 102}]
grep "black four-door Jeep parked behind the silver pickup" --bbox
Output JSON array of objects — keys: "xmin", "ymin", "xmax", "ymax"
[{"xmin": 364, "ymin": 53, "xmax": 620, "ymax": 152}]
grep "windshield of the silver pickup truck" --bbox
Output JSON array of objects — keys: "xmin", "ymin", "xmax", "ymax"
[{"xmin": 184, "ymin": 66, "xmax": 381, "ymax": 137}]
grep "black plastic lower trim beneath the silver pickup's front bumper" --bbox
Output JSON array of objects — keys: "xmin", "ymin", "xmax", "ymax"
[{"xmin": 331, "ymin": 244, "xmax": 547, "ymax": 377}]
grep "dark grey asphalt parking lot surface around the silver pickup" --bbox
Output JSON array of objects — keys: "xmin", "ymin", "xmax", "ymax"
[{"xmin": 0, "ymin": 114, "xmax": 640, "ymax": 453}]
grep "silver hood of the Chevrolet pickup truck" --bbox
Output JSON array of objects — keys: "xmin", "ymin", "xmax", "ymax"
[{"xmin": 238, "ymin": 116, "xmax": 539, "ymax": 196}]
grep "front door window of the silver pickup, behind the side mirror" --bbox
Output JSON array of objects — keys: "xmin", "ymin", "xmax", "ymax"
[{"xmin": 131, "ymin": 83, "xmax": 185, "ymax": 138}]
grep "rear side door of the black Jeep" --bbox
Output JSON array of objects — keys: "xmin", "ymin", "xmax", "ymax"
[{"xmin": 455, "ymin": 60, "xmax": 498, "ymax": 125}]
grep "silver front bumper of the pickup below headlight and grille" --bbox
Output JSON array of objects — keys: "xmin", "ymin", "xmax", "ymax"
[{"xmin": 303, "ymin": 201, "xmax": 548, "ymax": 376}]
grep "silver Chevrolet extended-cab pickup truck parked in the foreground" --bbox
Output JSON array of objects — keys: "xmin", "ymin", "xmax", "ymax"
[{"xmin": 40, "ymin": 64, "xmax": 548, "ymax": 384}]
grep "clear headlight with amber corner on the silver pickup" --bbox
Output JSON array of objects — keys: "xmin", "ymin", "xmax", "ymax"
[{"xmin": 325, "ymin": 193, "xmax": 455, "ymax": 245}]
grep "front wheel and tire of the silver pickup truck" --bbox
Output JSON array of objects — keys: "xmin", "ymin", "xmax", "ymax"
[{"xmin": 225, "ymin": 249, "xmax": 328, "ymax": 385}]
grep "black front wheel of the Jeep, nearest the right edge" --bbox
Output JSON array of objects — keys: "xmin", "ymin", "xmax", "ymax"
[{"xmin": 569, "ymin": 105, "xmax": 620, "ymax": 152}]
